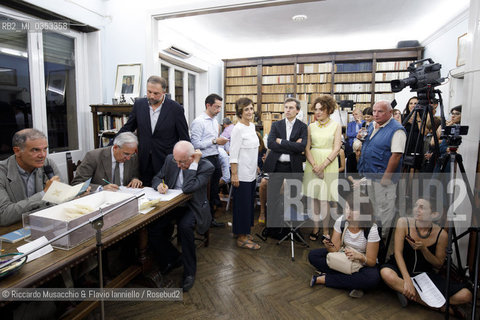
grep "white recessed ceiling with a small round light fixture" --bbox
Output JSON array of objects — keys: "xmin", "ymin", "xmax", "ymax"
[{"xmin": 160, "ymin": 0, "xmax": 470, "ymax": 58}]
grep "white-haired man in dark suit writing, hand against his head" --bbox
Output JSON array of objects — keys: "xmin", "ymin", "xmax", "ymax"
[{"xmin": 148, "ymin": 141, "xmax": 215, "ymax": 292}]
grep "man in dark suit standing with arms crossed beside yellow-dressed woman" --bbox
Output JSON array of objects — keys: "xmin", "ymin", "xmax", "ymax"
[{"xmin": 260, "ymin": 98, "xmax": 308, "ymax": 226}]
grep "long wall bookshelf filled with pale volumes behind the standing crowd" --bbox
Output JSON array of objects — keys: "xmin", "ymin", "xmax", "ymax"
[{"xmin": 224, "ymin": 47, "xmax": 423, "ymax": 133}]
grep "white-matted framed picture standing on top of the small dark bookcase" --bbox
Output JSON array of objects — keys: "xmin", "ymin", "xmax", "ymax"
[{"xmin": 114, "ymin": 64, "xmax": 142, "ymax": 103}]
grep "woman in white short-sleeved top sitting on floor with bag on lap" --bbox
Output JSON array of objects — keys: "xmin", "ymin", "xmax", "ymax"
[{"xmin": 308, "ymin": 192, "xmax": 381, "ymax": 298}]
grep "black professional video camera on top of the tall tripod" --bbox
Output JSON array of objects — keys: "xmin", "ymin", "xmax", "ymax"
[{"xmin": 390, "ymin": 58, "xmax": 444, "ymax": 92}]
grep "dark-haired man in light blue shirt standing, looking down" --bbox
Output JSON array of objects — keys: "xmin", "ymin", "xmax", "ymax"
[{"xmin": 190, "ymin": 93, "xmax": 228, "ymax": 227}]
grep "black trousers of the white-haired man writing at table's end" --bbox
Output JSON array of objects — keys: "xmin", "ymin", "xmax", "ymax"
[{"xmin": 148, "ymin": 207, "xmax": 197, "ymax": 277}]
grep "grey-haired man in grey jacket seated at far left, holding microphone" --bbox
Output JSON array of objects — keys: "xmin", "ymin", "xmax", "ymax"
[{"xmin": 0, "ymin": 129, "xmax": 60, "ymax": 226}]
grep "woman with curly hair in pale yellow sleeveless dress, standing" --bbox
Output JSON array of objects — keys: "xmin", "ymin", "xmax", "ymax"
[{"xmin": 303, "ymin": 95, "xmax": 342, "ymax": 241}]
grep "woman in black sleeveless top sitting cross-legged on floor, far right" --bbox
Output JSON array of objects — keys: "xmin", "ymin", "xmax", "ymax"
[{"xmin": 380, "ymin": 199, "xmax": 472, "ymax": 316}]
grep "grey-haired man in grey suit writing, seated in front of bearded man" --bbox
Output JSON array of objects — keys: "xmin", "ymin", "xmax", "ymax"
[{"xmin": 72, "ymin": 132, "xmax": 142, "ymax": 192}]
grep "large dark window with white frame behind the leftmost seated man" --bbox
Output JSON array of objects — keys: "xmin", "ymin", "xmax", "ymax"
[{"xmin": 0, "ymin": 7, "xmax": 84, "ymax": 162}]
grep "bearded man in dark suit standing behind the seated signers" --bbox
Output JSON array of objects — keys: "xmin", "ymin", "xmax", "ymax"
[{"xmin": 119, "ymin": 76, "xmax": 190, "ymax": 186}]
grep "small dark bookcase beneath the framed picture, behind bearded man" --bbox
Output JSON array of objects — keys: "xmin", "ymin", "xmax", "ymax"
[{"xmin": 90, "ymin": 104, "xmax": 133, "ymax": 149}]
